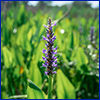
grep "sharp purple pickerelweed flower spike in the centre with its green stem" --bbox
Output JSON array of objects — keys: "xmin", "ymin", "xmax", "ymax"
[{"xmin": 42, "ymin": 18, "xmax": 57, "ymax": 99}]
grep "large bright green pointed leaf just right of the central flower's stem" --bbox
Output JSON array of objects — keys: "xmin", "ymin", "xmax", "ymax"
[{"xmin": 57, "ymin": 69, "xmax": 76, "ymax": 99}]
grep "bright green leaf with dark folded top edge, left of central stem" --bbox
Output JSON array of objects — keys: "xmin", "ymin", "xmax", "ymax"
[{"xmin": 27, "ymin": 80, "xmax": 44, "ymax": 99}]
